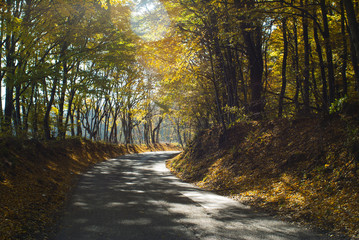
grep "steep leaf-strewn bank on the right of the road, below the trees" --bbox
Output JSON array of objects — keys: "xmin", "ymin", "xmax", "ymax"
[{"xmin": 167, "ymin": 118, "xmax": 359, "ymax": 239}]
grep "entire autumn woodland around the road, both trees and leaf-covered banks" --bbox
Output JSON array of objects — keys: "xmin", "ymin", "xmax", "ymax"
[{"xmin": 0, "ymin": 0, "xmax": 359, "ymax": 239}]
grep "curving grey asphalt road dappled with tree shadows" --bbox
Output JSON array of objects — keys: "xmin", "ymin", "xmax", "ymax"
[{"xmin": 55, "ymin": 152, "xmax": 338, "ymax": 240}]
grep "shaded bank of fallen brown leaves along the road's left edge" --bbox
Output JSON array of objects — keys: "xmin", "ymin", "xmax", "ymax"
[{"xmin": 0, "ymin": 138, "xmax": 178, "ymax": 240}]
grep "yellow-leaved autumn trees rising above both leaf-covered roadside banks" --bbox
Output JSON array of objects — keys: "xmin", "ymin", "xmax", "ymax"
[{"xmin": 0, "ymin": 0, "xmax": 359, "ymax": 144}]
